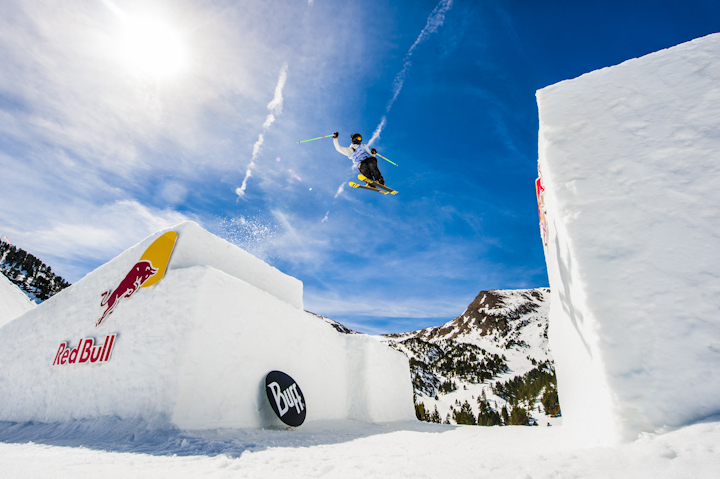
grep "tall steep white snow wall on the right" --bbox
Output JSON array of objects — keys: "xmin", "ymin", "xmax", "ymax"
[{"xmin": 537, "ymin": 34, "xmax": 720, "ymax": 443}]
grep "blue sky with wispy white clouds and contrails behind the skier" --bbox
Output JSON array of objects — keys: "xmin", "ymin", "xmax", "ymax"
[{"xmin": 0, "ymin": 0, "xmax": 720, "ymax": 333}]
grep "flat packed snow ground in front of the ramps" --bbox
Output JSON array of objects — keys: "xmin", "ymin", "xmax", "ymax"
[{"xmin": 0, "ymin": 421, "xmax": 720, "ymax": 479}]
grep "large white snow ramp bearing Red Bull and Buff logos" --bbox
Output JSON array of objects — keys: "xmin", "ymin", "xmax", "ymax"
[{"xmin": 0, "ymin": 222, "xmax": 415, "ymax": 429}]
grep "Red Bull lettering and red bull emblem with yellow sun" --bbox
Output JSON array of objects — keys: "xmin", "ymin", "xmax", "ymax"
[{"xmin": 53, "ymin": 231, "xmax": 177, "ymax": 366}]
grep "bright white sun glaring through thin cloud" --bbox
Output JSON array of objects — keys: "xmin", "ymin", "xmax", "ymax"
[{"xmin": 122, "ymin": 19, "xmax": 187, "ymax": 79}]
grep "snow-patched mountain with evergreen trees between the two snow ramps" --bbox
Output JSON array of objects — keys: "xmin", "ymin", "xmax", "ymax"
[{"xmin": 380, "ymin": 288, "xmax": 560, "ymax": 426}]
